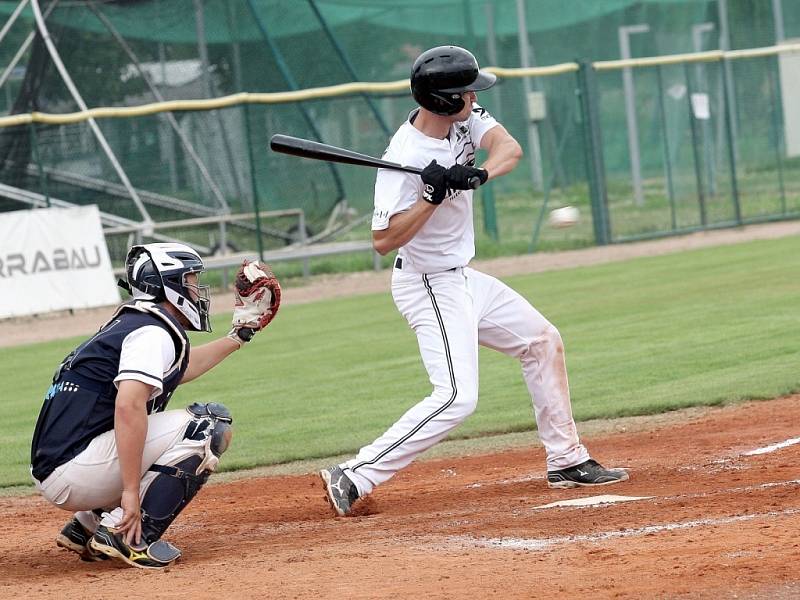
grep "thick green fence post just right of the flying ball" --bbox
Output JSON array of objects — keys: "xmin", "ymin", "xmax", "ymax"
[{"xmin": 578, "ymin": 61, "xmax": 611, "ymax": 246}]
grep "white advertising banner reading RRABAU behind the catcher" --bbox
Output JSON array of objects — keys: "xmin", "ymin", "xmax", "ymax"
[{"xmin": 0, "ymin": 206, "xmax": 120, "ymax": 319}]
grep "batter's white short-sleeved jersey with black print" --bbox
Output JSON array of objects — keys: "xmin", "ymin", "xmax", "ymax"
[{"xmin": 372, "ymin": 104, "xmax": 497, "ymax": 273}]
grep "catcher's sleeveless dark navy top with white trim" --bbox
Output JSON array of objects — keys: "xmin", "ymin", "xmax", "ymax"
[{"xmin": 31, "ymin": 301, "xmax": 189, "ymax": 481}]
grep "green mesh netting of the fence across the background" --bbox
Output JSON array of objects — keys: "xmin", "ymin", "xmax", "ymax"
[{"xmin": 0, "ymin": 0, "xmax": 800, "ymax": 264}]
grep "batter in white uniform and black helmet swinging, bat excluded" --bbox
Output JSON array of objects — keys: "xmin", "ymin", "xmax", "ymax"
[{"xmin": 320, "ymin": 46, "xmax": 628, "ymax": 516}]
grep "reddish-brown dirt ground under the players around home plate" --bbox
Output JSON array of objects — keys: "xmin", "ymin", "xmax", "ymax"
[{"xmin": 0, "ymin": 396, "xmax": 800, "ymax": 600}]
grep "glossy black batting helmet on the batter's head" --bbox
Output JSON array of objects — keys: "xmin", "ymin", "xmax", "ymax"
[{"xmin": 411, "ymin": 46, "xmax": 497, "ymax": 115}]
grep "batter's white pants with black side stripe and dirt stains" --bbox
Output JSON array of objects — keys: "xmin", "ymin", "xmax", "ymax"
[{"xmin": 342, "ymin": 267, "xmax": 589, "ymax": 496}]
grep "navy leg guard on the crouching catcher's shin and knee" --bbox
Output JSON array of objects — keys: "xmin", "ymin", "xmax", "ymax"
[{"xmin": 141, "ymin": 402, "xmax": 233, "ymax": 548}]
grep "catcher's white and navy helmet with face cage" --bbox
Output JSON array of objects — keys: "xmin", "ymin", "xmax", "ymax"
[{"xmin": 120, "ymin": 243, "xmax": 211, "ymax": 331}]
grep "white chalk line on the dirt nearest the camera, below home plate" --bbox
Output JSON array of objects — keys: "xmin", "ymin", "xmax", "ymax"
[{"xmin": 450, "ymin": 508, "xmax": 800, "ymax": 551}]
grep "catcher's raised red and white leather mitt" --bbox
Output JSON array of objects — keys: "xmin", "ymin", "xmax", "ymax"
[{"xmin": 228, "ymin": 260, "xmax": 281, "ymax": 346}]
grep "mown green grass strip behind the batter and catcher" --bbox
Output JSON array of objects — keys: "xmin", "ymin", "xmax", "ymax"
[{"xmin": 0, "ymin": 237, "xmax": 800, "ymax": 487}]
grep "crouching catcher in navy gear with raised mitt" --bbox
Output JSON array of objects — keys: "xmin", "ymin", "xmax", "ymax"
[{"xmin": 31, "ymin": 244, "xmax": 280, "ymax": 569}]
